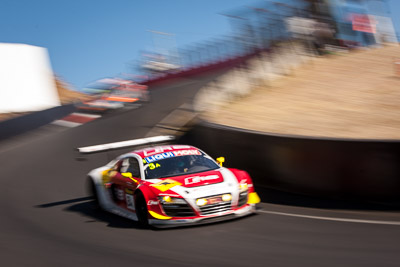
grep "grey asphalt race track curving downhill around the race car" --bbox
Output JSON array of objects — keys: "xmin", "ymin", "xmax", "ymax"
[{"xmin": 0, "ymin": 71, "xmax": 400, "ymax": 266}]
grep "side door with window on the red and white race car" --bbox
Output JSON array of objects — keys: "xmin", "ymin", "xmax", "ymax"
[{"xmin": 111, "ymin": 157, "xmax": 141, "ymax": 210}]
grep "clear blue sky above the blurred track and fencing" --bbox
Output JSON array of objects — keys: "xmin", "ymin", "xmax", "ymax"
[{"xmin": 0, "ymin": 0, "xmax": 400, "ymax": 89}]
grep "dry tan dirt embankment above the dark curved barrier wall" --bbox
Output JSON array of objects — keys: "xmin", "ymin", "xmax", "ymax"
[{"xmin": 204, "ymin": 45, "xmax": 400, "ymax": 139}]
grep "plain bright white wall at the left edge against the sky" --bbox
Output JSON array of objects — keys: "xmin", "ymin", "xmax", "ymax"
[{"xmin": 0, "ymin": 43, "xmax": 60, "ymax": 113}]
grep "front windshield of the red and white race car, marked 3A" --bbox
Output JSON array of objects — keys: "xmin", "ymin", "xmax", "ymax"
[{"xmin": 144, "ymin": 154, "xmax": 220, "ymax": 179}]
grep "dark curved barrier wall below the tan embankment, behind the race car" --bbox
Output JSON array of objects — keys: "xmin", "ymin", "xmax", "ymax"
[{"xmin": 180, "ymin": 121, "xmax": 400, "ymax": 202}]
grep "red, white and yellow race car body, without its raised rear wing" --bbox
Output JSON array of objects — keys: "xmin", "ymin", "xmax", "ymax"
[{"xmin": 81, "ymin": 138, "xmax": 260, "ymax": 227}]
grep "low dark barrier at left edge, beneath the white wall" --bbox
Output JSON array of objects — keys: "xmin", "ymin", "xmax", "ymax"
[{"xmin": 0, "ymin": 104, "xmax": 76, "ymax": 140}]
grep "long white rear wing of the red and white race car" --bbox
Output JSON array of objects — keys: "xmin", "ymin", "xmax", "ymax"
[{"xmin": 76, "ymin": 135, "xmax": 175, "ymax": 154}]
